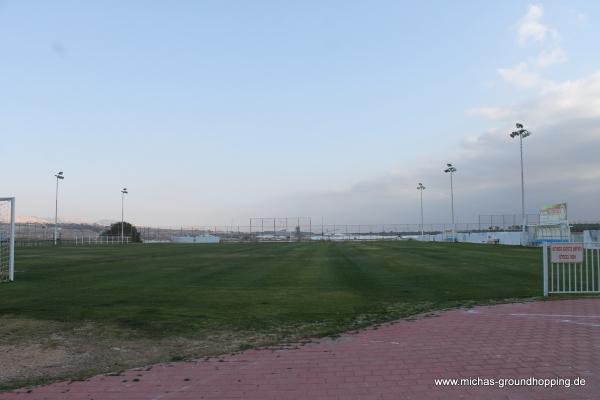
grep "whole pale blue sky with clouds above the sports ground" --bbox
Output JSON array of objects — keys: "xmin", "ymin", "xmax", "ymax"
[{"xmin": 0, "ymin": 0, "xmax": 600, "ymax": 226}]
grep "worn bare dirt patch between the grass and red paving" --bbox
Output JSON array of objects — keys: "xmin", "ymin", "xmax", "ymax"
[{"xmin": 0, "ymin": 318, "xmax": 275, "ymax": 389}]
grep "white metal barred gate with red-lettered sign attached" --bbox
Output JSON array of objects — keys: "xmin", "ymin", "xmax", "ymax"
[{"xmin": 542, "ymin": 243, "xmax": 600, "ymax": 296}]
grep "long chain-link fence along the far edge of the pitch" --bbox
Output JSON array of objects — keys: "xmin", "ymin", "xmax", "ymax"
[{"xmin": 16, "ymin": 214, "xmax": 600, "ymax": 246}]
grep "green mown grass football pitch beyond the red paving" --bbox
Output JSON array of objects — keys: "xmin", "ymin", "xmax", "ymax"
[{"xmin": 0, "ymin": 241, "xmax": 542, "ymax": 386}]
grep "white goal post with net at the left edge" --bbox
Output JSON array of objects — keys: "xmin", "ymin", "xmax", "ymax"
[{"xmin": 0, "ymin": 197, "xmax": 15, "ymax": 282}]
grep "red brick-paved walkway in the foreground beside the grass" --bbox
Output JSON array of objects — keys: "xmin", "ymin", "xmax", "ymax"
[{"xmin": 0, "ymin": 299, "xmax": 600, "ymax": 400}]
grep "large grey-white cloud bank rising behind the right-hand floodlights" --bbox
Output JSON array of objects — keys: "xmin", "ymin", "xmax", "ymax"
[{"xmin": 285, "ymin": 71, "xmax": 600, "ymax": 223}]
